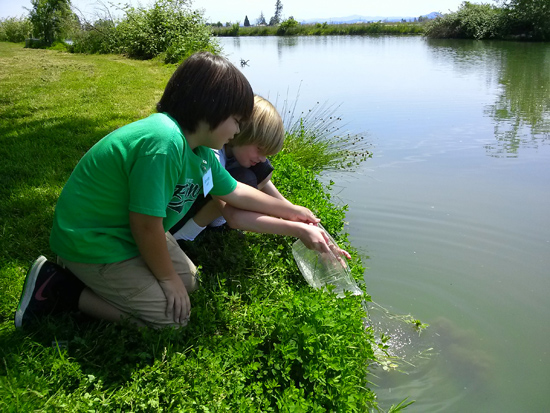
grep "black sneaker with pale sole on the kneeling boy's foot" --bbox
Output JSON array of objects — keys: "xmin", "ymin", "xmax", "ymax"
[{"xmin": 15, "ymin": 256, "xmax": 65, "ymax": 328}]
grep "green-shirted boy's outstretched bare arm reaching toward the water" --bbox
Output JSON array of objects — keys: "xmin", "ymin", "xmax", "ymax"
[{"xmin": 218, "ymin": 182, "xmax": 320, "ymax": 224}]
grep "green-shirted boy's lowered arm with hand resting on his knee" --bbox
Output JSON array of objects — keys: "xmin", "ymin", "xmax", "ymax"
[{"xmin": 130, "ymin": 211, "xmax": 191, "ymax": 324}]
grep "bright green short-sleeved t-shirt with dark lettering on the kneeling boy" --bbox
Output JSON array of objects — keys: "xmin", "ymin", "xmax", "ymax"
[{"xmin": 50, "ymin": 113, "xmax": 237, "ymax": 264}]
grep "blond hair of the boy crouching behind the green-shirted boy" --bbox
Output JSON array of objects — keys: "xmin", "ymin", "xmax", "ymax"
[{"xmin": 229, "ymin": 95, "xmax": 285, "ymax": 155}]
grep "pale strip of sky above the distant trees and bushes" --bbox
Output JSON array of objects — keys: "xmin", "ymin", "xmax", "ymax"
[{"xmin": 0, "ymin": 0, "xmax": 472, "ymax": 23}]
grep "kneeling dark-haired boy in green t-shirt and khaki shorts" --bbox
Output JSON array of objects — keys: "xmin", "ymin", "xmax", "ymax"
[{"xmin": 15, "ymin": 52, "xmax": 328, "ymax": 327}]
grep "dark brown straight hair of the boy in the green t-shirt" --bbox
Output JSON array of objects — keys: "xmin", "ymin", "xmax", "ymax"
[{"xmin": 157, "ymin": 52, "xmax": 254, "ymax": 133}]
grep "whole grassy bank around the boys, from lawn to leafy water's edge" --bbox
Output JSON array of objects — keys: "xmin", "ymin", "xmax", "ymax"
[{"xmin": 0, "ymin": 43, "xmax": 388, "ymax": 412}]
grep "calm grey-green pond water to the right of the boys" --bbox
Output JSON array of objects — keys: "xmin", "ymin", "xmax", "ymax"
[{"xmin": 221, "ymin": 36, "xmax": 550, "ymax": 412}]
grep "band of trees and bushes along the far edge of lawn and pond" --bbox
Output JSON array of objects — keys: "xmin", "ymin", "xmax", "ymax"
[{"xmin": 0, "ymin": 0, "xmax": 550, "ymax": 54}]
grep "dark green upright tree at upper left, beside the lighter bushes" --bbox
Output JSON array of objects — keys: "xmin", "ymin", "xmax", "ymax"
[{"xmin": 29, "ymin": 0, "xmax": 74, "ymax": 46}]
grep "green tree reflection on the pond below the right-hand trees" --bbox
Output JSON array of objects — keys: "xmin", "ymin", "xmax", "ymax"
[{"xmin": 427, "ymin": 39, "xmax": 550, "ymax": 157}]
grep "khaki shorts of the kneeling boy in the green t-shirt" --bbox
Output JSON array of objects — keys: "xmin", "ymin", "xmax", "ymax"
[{"xmin": 58, "ymin": 232, "xmax": 198, "ymax": 328}]
